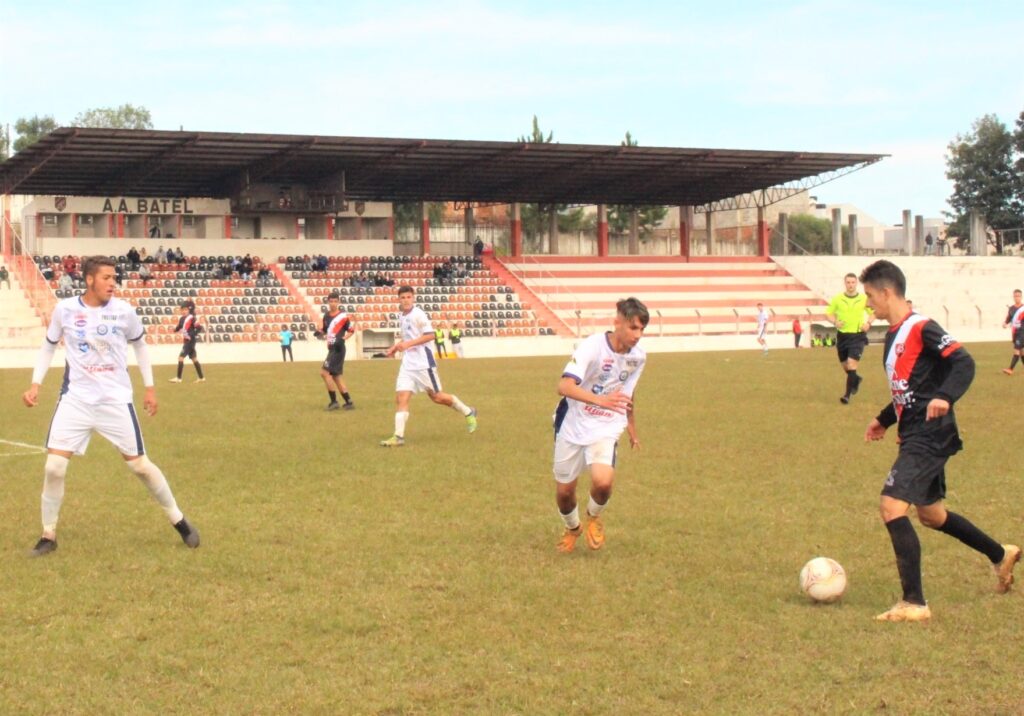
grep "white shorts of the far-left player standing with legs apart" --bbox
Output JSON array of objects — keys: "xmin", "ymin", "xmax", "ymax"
[{"xmin": 46, "ymin": 395, "xmax": 145, "ymax": 456}]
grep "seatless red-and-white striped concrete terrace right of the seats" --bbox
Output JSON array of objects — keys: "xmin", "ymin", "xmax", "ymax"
[{"xmin": 502, "ymin": 256, "xmax": 825, "ymax": 335}]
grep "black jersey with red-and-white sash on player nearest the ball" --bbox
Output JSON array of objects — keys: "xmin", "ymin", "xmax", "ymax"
[{"xmin": 878, "ymin": 313, "xmax": 974, "ymax": 455}]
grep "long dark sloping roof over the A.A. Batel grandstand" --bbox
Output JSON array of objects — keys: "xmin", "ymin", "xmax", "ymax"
[{"xmin": 0, "ymin": 127, "xmax": 886, "ymax": 206}]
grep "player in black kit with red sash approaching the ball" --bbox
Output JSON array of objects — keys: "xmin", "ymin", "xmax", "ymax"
[{"xmin": 860, "ymin": 261, "xmax": 1021, "ymax": 622}]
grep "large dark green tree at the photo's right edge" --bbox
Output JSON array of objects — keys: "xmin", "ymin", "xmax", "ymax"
[{"xmin": 946, "ymin": 114, "xmax": 1024, "ymax": 243}]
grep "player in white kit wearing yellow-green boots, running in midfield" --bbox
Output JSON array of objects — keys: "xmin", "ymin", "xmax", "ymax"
[{"xmin": 381, "ymin": 286, "xmax": 476, "ymax": 448}]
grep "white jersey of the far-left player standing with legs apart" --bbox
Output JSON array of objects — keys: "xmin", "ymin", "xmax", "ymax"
[{"xmin": 46, "ymin": 297, "xmax": 145, "ymax": 405}]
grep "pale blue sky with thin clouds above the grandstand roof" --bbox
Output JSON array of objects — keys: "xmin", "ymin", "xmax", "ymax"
[{"xmin": 0, "ymin": 0, "xmax": 1024, "ymax": 223}]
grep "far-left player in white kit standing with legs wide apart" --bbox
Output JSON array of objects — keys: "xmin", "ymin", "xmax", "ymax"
[{"xmin": 22, "ymin": 256, "xmax": 199, "ymax": 556}]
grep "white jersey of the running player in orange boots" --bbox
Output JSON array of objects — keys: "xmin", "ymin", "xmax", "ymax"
[{"xmin": 555, "ymin": 333, "xmax": 647, "ymax": 445}]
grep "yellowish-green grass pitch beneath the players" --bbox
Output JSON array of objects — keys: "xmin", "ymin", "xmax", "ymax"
[{"xmin": 0, "ymin": 344, "xmax": 1024, "ymax": 714}]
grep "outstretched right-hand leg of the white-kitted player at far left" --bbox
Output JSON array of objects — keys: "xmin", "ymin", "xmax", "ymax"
[{"xmin": 96, "ymin": 403, "xmax": 199, "ymax": 548}]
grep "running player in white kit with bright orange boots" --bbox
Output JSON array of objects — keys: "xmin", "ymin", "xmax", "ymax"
[{"xmin": 554, "ymin": 298, "xmax": 650, "ymax": 552}]
